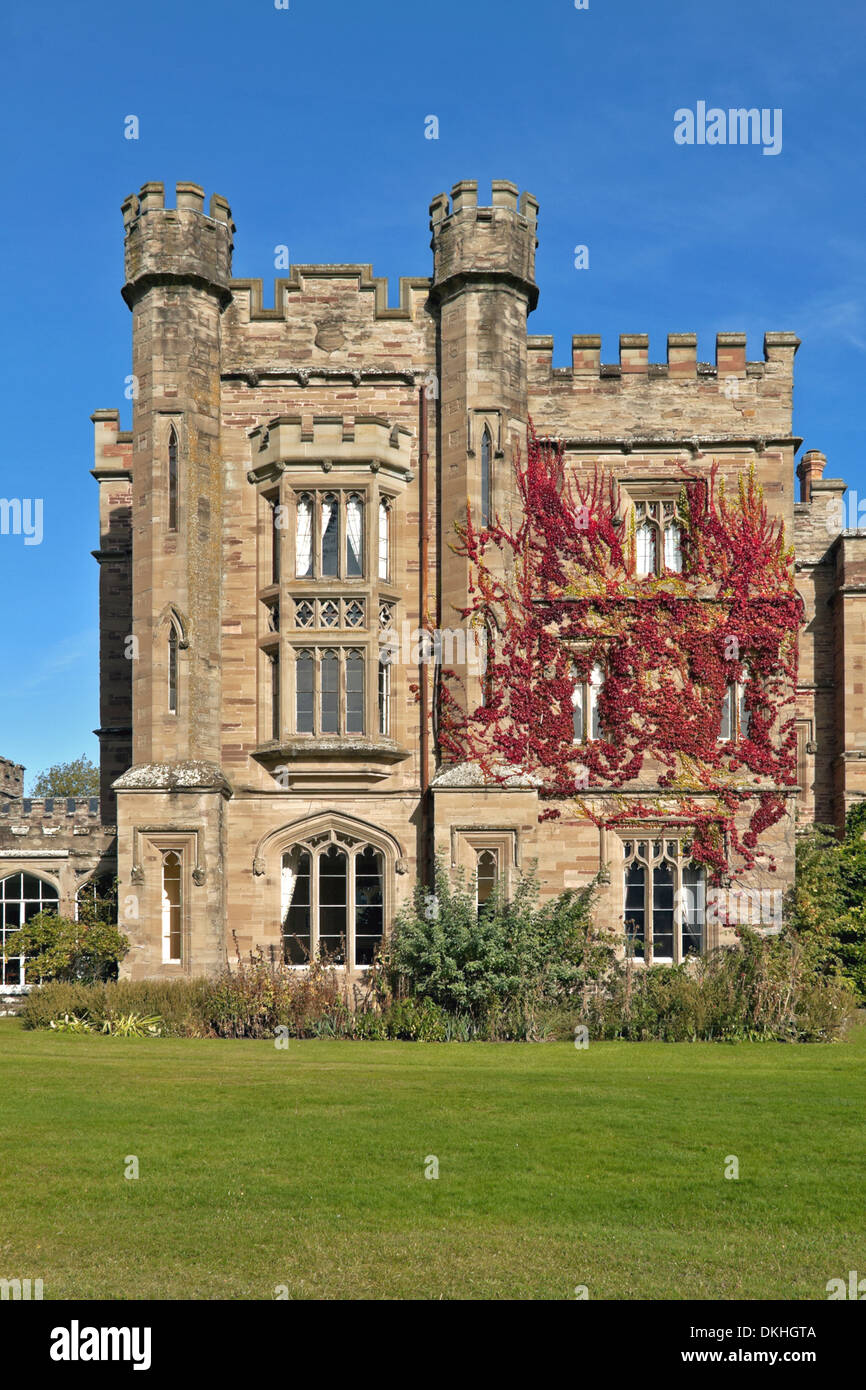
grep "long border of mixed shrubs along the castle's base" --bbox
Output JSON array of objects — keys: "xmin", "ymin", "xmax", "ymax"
[{"xmin": 22, "ymin": 911, "xmax": 856, "ymax": 1043}]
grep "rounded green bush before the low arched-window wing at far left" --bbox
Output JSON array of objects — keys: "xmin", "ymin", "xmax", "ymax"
[{"xmin": 4, "ymin": 912, "xmax": 129, "ymax": 984}]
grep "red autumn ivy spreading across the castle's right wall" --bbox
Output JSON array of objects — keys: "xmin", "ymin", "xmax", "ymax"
[{"xmin": 439, "ymin": 431, "xmax": 802, "ymax": 880}]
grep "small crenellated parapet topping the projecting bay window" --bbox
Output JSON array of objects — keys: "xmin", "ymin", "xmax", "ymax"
[{"xmin": 247, "ymin": 416, "xmax": 413, "ymax": 482}]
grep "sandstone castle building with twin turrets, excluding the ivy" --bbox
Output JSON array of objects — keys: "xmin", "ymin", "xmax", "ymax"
[{"xmin": 0, "ymin": 181, "xmax": 866, "ymax": 977}]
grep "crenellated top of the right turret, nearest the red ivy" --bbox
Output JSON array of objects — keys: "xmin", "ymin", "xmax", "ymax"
[{"xmin": 430, "ymin": 179, "xmax": 538, "ymax": 309}]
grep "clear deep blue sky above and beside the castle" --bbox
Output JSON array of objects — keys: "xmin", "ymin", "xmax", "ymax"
[{"xmin": 0, "ymin": 0, "xmax": 866, "ymax": 795}]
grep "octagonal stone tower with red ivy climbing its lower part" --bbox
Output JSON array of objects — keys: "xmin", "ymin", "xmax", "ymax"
[{"xmin": 430, "ymin": 179, "xmax": 538, "ymax": 722}]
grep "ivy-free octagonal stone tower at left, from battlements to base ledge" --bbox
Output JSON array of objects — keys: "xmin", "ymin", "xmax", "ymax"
[{"xmin": 122, "ymin": 183, "xmax": 235, "ymax": 765}]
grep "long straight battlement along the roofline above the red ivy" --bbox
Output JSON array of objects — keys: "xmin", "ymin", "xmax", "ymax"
[{"xmin": 528, "ymin": 332, "xmax": 799, "ymax": 386}]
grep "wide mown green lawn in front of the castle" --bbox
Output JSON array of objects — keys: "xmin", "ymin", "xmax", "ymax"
[{"xmin": 0, "ymin": 1019, "xmax": 866, "ymax": 1298}]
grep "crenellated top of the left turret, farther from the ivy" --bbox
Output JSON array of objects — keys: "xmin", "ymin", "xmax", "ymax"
[{"xmin": 121, "ymin": 183, "xmax": 235, "ymax": 307}]
